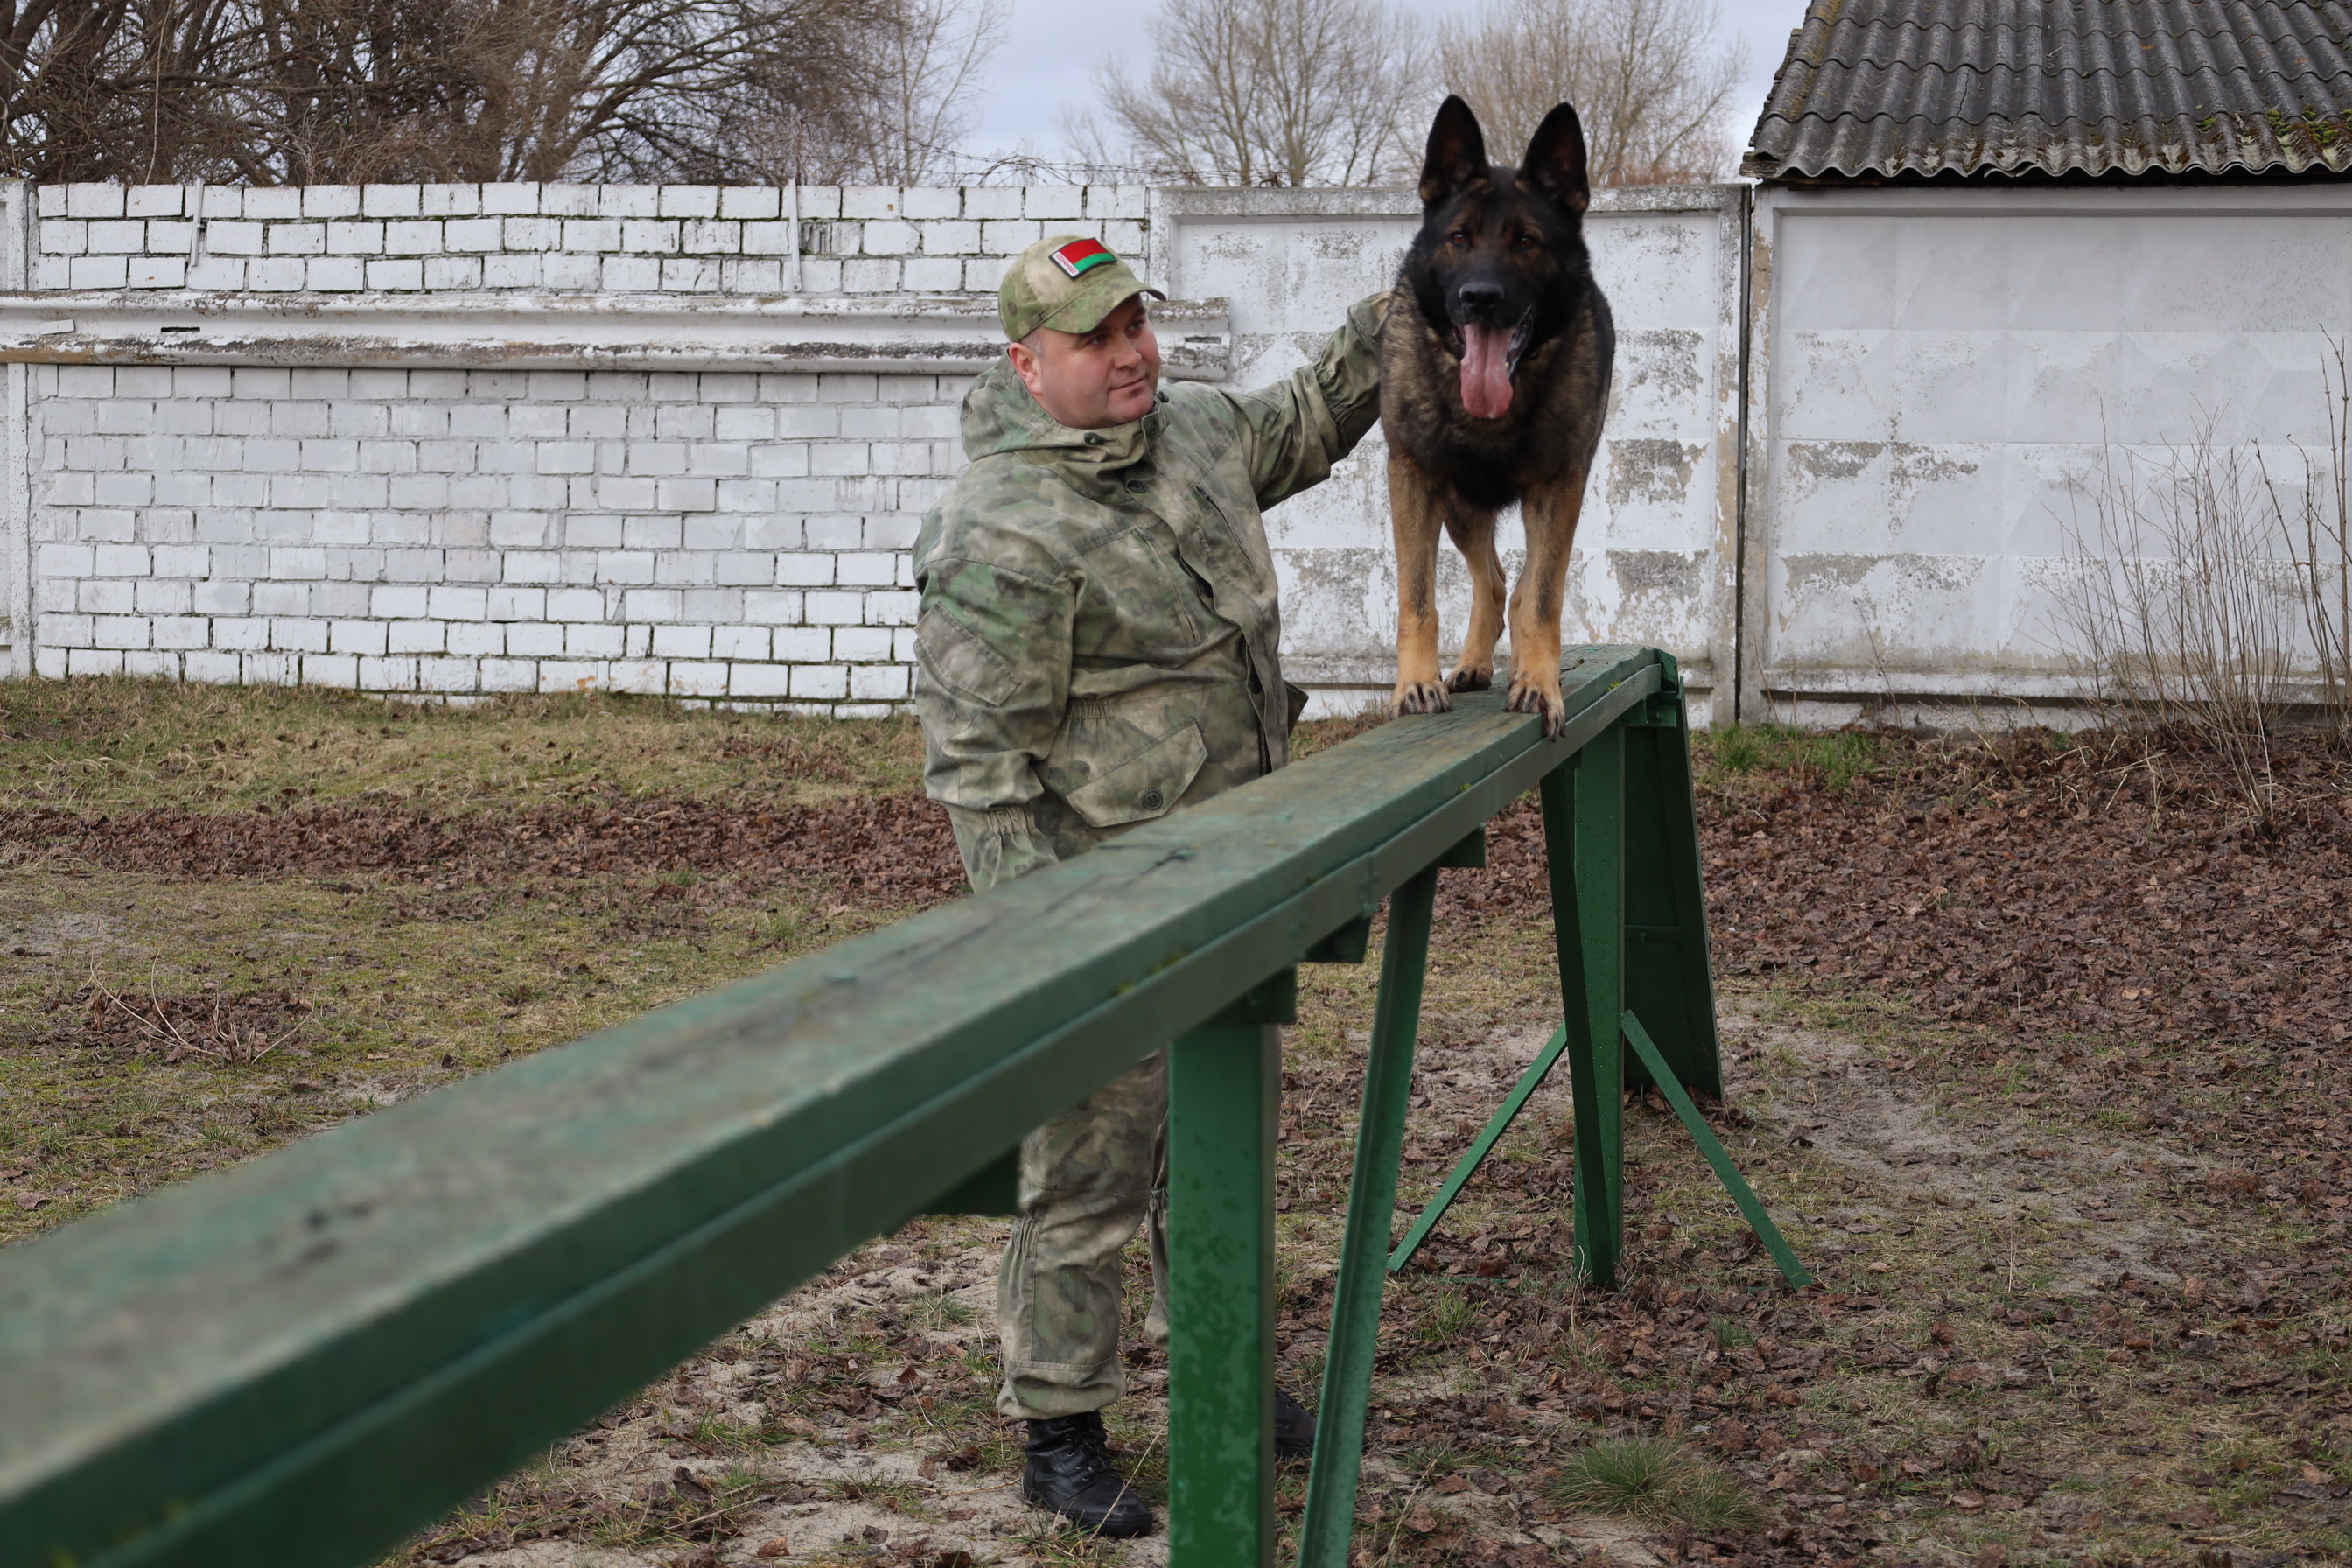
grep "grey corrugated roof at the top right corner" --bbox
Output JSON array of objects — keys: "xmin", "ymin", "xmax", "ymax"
[{"xmin": 1745, "ymin": 0, "xmax": 2352, "ymax": 178}]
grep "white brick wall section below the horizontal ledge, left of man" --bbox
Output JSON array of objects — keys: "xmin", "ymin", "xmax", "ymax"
[{"xmin": 33, "ymin": 367, "xmax": 962, "ymax": 705}]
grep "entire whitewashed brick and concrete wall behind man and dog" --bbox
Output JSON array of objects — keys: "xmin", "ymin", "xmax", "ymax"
[{"xmin": 23, "ymin": 184, "xmax": 2352, "ymax": 719}]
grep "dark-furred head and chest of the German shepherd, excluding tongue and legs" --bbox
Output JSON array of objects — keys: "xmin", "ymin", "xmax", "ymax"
[{"xmin": 1381, "ymin": 99, "xmax": 1616, "ymax": 508}]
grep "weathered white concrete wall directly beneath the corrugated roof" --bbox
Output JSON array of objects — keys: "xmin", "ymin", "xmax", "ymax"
[{"xmin": 1743, "ymin": 184, "xmax": 2352, "ymax": 719}]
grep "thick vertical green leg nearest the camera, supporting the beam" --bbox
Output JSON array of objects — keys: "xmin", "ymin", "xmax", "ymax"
[{"xmin": 1169, "ymin": 969, "xmax": 1298, "ymax": 1568}]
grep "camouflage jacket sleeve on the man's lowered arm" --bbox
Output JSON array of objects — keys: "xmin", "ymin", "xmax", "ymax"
[{"xmin": 915, "ymin": 557, "xmax": 1077, "ymax": 891}]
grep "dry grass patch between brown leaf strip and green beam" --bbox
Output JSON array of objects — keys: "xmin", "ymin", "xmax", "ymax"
[{"xmin": 0, "ymin": 870, "xmax": 889, "ymax": 1242}]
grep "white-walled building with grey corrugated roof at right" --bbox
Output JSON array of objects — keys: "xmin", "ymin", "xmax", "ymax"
[{"xmin": 1738, "ymin": 0, "xmax": 2352, "ymax": 719}]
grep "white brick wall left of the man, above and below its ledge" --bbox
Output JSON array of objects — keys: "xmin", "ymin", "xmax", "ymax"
[{"xmin": 10, "ymin": 186, "xmax": 1150, "ymax": 712}]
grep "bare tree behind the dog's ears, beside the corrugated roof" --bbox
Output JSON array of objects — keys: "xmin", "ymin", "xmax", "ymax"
[{"xmin": 1437, "ymin": 0, "xmax": 1747, "ymax": 186}]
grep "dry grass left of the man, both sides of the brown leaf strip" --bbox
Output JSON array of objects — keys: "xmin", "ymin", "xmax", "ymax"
[{"xmin": 0, "ymin": 679, "xmax": 920, "ymax": 1242}]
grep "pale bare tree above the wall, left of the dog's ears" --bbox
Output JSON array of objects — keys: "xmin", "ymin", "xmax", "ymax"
[{"xmin": 1066, "ymin": 0, "xmax": 1425, "ymax": 186}]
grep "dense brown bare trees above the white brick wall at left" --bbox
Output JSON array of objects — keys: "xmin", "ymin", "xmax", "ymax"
[{"xmin": 0, "ymin": 0, "xmax": 978, "ymax": 184}]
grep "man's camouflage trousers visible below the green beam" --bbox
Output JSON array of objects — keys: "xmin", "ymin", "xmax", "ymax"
[{"xmin": 998, "ymin": 1054, "xmax": 1169, "ymax": 1420}]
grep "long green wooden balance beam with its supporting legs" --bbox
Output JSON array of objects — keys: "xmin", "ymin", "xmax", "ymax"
[{"xmin": 0, "ymin": 649, "xmax": 1796, "ymax": 1568}]
